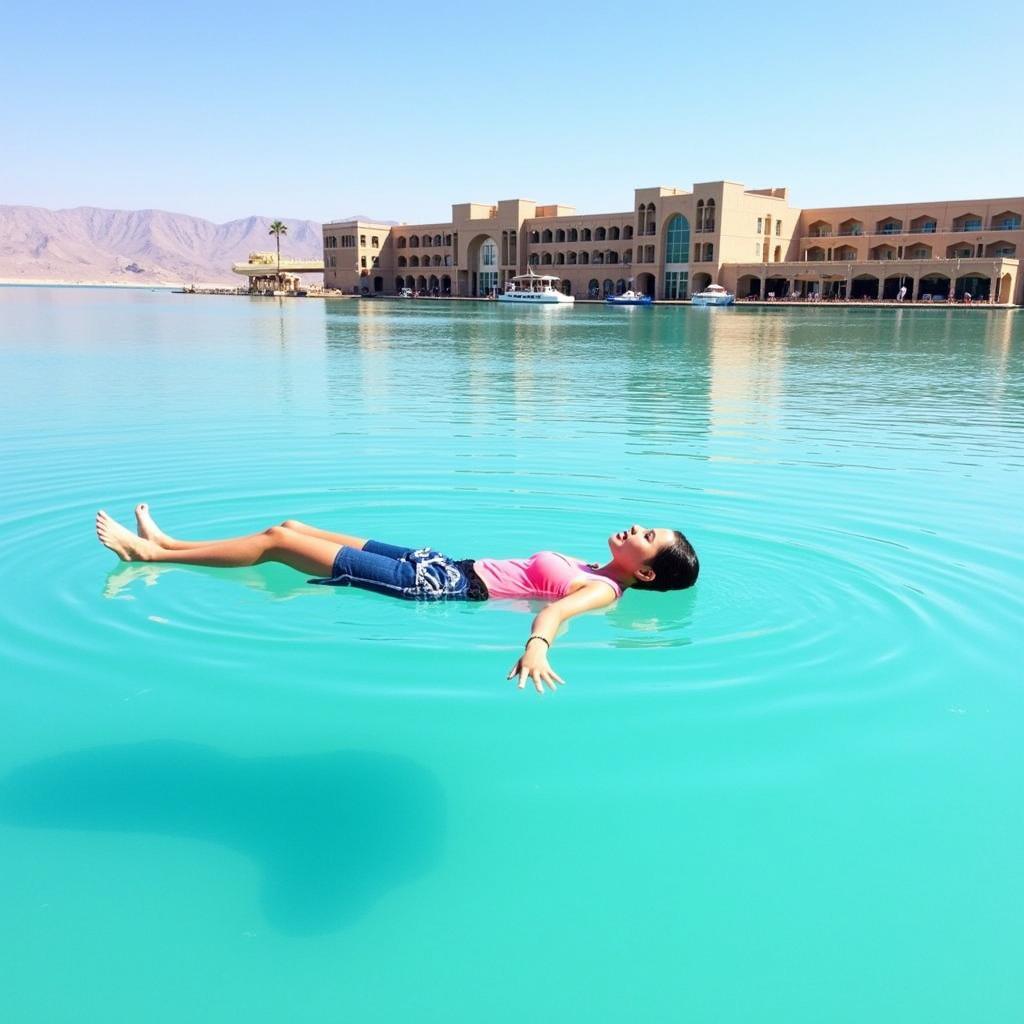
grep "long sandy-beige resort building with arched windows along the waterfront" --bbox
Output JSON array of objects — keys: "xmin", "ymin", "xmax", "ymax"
[{"xmin": 324, "ymin": 181, "xmax": 1024, "ymax": 304}]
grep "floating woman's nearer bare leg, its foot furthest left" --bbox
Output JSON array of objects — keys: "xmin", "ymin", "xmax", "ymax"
[{"xmin": 96, "ymin": 511, "xmax": 340, "ymax": 575}]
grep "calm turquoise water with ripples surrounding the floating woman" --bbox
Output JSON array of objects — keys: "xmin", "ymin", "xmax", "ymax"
[{"xmin": 0, "ymin": 288, "xmax": 1024, "ymax": 1024}]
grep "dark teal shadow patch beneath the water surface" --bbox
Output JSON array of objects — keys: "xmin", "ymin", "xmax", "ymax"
[{"xmin": 0, "ymin": 742, "xmax": 444, "ymax": 935}]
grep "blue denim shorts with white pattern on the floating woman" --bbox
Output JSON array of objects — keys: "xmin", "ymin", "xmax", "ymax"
[{"xmin": 309, "ymin": 541, "xmax": 487, "ymax": 601}]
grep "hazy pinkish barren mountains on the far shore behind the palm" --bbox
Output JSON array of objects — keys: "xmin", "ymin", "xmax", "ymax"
[{"xmin": 0, "ymin": 206, "xmax": 323, "ymax": 285}]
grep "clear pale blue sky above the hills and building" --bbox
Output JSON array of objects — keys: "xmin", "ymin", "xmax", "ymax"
[{"xmin": 0, "ymin": 0, "xmax": 1024, "ymax": 221}]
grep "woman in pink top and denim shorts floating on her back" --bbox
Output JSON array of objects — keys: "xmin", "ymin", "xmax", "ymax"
[{"xmin": 96, "ymin": 503, "xmax": 700, "ymax": 693}]
